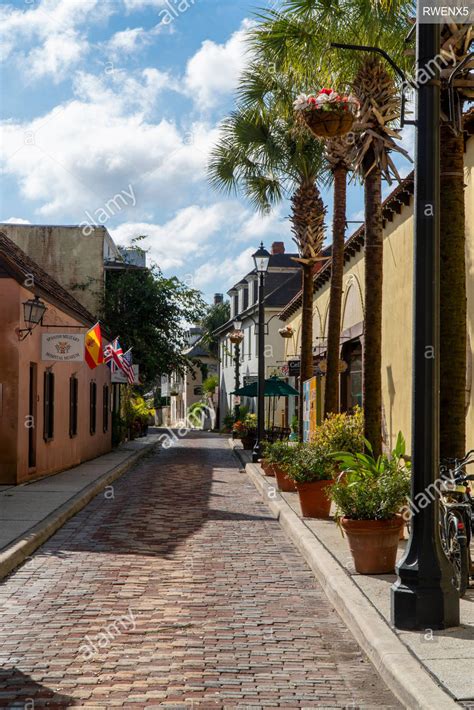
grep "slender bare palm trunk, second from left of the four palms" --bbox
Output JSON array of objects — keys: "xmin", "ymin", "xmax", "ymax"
[{"xmin": 324, "ymin": 165, "xmax": 347, "ymax": 417}]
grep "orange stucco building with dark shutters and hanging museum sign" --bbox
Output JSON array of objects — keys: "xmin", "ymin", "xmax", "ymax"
[{"xmin": 0, "ymin": 232, "xmax": 112, "ymax": 485}]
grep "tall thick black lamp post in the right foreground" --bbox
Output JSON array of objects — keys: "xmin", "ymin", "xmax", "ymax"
[{"xmin": 392, "ymin": 16, "xmax": 459, "ymax": 629}]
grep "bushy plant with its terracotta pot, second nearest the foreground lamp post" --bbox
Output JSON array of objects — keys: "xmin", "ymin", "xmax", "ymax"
[{"xmin": 288, "ymin": 443, "xmax": 334, "ymax": 519}]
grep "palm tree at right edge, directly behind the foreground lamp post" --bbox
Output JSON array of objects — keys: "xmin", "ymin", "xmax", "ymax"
[{"xmin": 440, "ymin": 23, "xmax": 474, "ymax": 458}]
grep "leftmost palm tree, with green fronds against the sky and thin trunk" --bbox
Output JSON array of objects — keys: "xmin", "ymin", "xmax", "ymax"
[{"xmin": 209, "ymin": 63, "xmax": 325, "ymax": 437}]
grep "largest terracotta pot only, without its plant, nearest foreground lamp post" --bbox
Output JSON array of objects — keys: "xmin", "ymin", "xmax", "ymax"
[{"xmin": 341, "ymin": 515, "xmax": 403, "ymax": 574}]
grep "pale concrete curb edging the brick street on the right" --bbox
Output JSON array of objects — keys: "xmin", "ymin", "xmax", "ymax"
[{"xmin": 233, "ymin": 447, "xmax": 459, "ymax": 710}]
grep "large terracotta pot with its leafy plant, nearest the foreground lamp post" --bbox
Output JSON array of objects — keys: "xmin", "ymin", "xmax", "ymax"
[{"xmin": 330, "ymin": 433, "xmax": 410, "ymax": 574}]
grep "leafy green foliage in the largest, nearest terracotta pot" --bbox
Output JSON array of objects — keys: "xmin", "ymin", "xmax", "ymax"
[{"xmin": 330, "ymin": 432, "xmax": 410, "ymax": 520}]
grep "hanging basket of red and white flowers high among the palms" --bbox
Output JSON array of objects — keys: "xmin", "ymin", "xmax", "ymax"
[{"xmin": 294, "ymin": 89, "xmax": 359, "ymax": 138}]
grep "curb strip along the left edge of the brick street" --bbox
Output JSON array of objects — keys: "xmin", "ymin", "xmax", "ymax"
[{"xmin": 0, "ymin": 441, "xmax": 158, "ymax": 579}]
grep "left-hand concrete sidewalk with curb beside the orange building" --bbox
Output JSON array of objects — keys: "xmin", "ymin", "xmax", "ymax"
[{"xmin": 0, "ymin": 433, "xmax": 159, "ymax": 579}]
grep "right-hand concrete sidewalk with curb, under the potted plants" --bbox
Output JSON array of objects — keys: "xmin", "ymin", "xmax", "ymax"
[{"xmin": 230, "ymin": 441, "xmax": 474, "ymax": 710}]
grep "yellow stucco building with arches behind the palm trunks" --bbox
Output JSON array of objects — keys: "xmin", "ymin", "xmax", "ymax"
[{"xmin": 280, "ymin": 136, "xmax": 474, "ymax": 456}]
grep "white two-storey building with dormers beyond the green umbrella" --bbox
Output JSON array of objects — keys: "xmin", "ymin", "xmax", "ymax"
[{"xmin": 215, "ymin": 242, "xmax": 301, "ymax": 427}]
